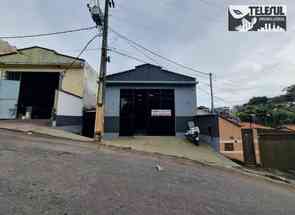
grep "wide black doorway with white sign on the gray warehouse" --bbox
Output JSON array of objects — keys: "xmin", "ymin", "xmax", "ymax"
[{"xmin": 120, "ymin": 89, "xmax": 175, "ymax": 136}]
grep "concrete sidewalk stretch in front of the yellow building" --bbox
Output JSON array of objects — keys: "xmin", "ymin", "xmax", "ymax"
[{"xmin": 0, "ymin": 120, "xmax": 93, "ymax": 142}]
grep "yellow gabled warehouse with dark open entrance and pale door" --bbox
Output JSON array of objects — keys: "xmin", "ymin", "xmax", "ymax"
[{"xmin": 0, "ymin": 46, "xmax": 97, "ymax": 133}]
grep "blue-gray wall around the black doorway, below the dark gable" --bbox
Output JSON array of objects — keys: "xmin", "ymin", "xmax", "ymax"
[{"xmin": 105, "ymin": 85, "xmax": 196, "ymax": 136}]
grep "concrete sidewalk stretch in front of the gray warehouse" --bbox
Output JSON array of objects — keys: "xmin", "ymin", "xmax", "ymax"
[{"xmin": 103, "ymin": 136, "xmax": 239, "ymax": 168}]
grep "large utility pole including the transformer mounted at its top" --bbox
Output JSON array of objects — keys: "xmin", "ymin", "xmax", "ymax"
[{"xmin": 88, "ymin": 0, "xmax": 115, "ymax": 141}]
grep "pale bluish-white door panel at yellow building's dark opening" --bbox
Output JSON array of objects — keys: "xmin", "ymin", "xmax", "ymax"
[{"xmin": 0, "ymin": 80, "xmax": 20, "ymax": 119}]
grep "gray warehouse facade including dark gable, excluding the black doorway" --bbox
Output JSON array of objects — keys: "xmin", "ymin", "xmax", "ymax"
[{"xmin": 105, "ymin": 64, "xmax": 197, "ymax": 137}]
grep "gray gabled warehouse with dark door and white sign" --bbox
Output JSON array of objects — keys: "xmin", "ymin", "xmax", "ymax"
[{"xmin": 105, "ymin": 64, "xmax": 197, "ymax": 137}]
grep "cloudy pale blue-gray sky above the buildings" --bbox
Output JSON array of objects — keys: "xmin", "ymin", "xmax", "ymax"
[{"xmin": 0, "ymin": 0, "xmax": 295, "ymax": 106}]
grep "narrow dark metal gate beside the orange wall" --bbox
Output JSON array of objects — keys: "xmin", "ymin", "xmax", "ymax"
[{"xmin": 242, "ymin": 129, "xmax": 256, "ymax": 166}]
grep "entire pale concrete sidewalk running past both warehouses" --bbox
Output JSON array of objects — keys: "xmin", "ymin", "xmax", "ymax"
[{"xmin": 0, "ymin": 121, "xmax": 239, "ymax": 168}]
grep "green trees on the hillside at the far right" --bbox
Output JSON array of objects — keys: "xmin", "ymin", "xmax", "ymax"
[{"xmin": 236, "ymin": 85, "xmax": 295, "ymax": 127}]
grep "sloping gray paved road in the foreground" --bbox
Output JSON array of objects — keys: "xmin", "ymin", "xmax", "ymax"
[{"xmin": 0, "ymin": 130, "xmax": 295, "ymax": 215}]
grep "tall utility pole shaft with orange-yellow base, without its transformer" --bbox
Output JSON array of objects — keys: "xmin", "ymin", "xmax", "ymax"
[{"xmin": 94, "ymin": 0, "xmax": 110, "ymax": 141}]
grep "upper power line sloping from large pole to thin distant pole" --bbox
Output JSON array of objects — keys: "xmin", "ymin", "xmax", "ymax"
[{"xmin": 110, "ymin": 28, "xmax": 209, "ymax": 76}]
